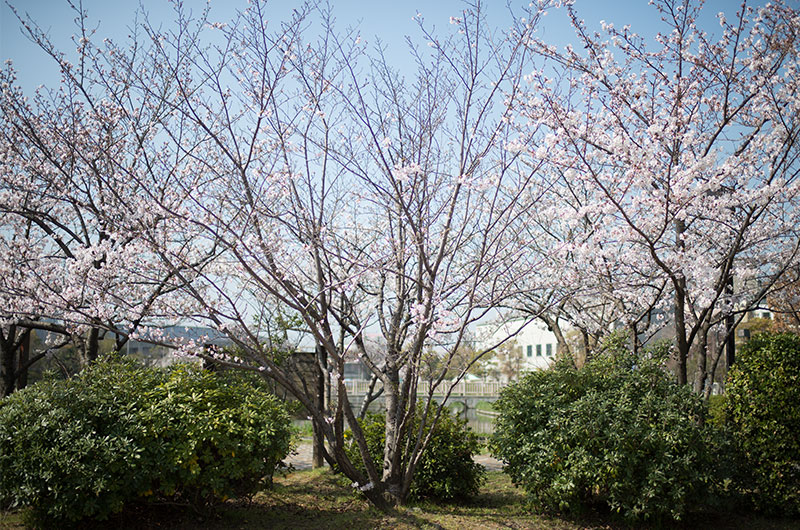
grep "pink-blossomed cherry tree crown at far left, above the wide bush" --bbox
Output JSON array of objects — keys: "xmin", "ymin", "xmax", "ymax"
[{"xmin": 0, "ymin": 2, "xmax": 213, "ymax": 393}]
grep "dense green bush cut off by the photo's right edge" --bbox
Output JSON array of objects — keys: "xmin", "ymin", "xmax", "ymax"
[{"xmin": 726, "ymin": 333, "xmax": 800, "ymax": 515}]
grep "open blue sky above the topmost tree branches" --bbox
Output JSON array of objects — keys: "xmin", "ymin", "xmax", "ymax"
[{"xmin": 0, "ymin": 0, "xmax": 756, "ymax": 92}]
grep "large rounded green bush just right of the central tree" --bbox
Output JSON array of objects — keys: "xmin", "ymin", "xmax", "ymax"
[{"xmin": 490, "ymin": 340, "xmax": 714, "ymax": 522}]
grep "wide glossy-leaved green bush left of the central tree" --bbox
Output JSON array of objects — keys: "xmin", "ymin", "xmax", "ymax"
[{"xmin": 0, "ymin": 352, "xmax": 290, "ymax": 524}]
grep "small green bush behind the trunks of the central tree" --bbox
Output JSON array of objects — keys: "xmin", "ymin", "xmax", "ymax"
[{"xmin": 346, "ymin": 405, "xmax": 486, "ymax": 500}]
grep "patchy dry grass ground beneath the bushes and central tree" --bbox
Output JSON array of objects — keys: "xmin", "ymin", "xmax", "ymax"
[{"xmin": 0, "ymin": 470, "xmax": 798, "ymax": 530}]
